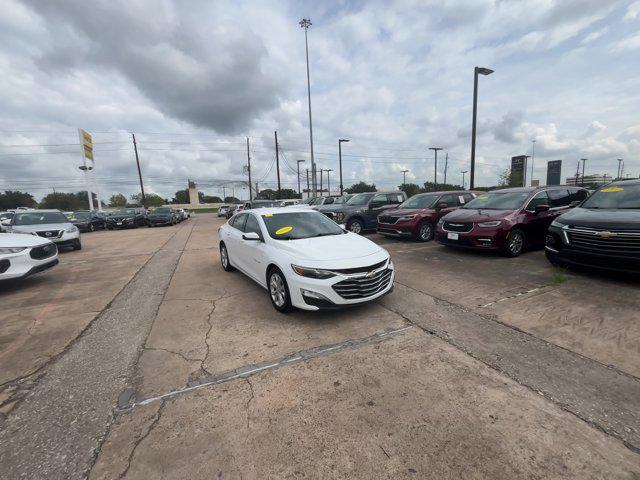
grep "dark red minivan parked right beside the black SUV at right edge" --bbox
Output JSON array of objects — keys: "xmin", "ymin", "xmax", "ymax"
[{"xmin": 436, "ymin": 186, "xmax": 589, "ymax": 257}]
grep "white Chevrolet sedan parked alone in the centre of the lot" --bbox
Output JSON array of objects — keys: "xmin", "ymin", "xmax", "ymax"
[{"xmin": 219, "ymin": 207, "xmax": 394, "ymax": 312}]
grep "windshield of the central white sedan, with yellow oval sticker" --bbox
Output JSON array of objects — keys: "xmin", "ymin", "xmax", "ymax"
[{"xmin": 262, "ymin": 211, "xmax": 346, "ymax": 240}]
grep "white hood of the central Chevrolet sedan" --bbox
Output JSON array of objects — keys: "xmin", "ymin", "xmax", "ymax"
[{"xmin": 274, "ymin": 233, "xmax": 389, "ymax": 268}]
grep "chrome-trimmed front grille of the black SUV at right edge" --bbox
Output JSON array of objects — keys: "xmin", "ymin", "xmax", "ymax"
[{"xmin": 565, "ymin": 227, "xmax": 640, "ymax": 254}]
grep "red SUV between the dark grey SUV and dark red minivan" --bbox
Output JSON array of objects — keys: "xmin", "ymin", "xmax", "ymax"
[{"xmin": 378, "ymin": 190, "xmax": 480, "ymax": 242}]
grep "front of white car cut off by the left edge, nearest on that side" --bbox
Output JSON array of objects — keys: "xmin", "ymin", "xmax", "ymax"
[{"xmin": 0, "ymin": 233, "xmax": 58, "ymax": 280}]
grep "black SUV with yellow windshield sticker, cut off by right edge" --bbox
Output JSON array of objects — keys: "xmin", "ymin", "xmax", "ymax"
[{"xmin": 545, "ymin": 180, "xmax": 640, "ymax": 273}]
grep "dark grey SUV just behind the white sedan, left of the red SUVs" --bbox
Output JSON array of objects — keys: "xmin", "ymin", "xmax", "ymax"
[{"xmin": 321, "ymin": 190, "xmax": 407, "ymax": 233}]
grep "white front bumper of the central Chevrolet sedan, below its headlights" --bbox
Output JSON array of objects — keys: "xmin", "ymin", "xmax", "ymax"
[{"xmin": 286, "ymin": 261, "xmax": 395, "ymax": 310}]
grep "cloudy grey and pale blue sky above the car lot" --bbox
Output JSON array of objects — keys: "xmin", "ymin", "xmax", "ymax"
[{"xmin": 0, "ymin": 0, "xmax": 640, "ymax": 202}]
